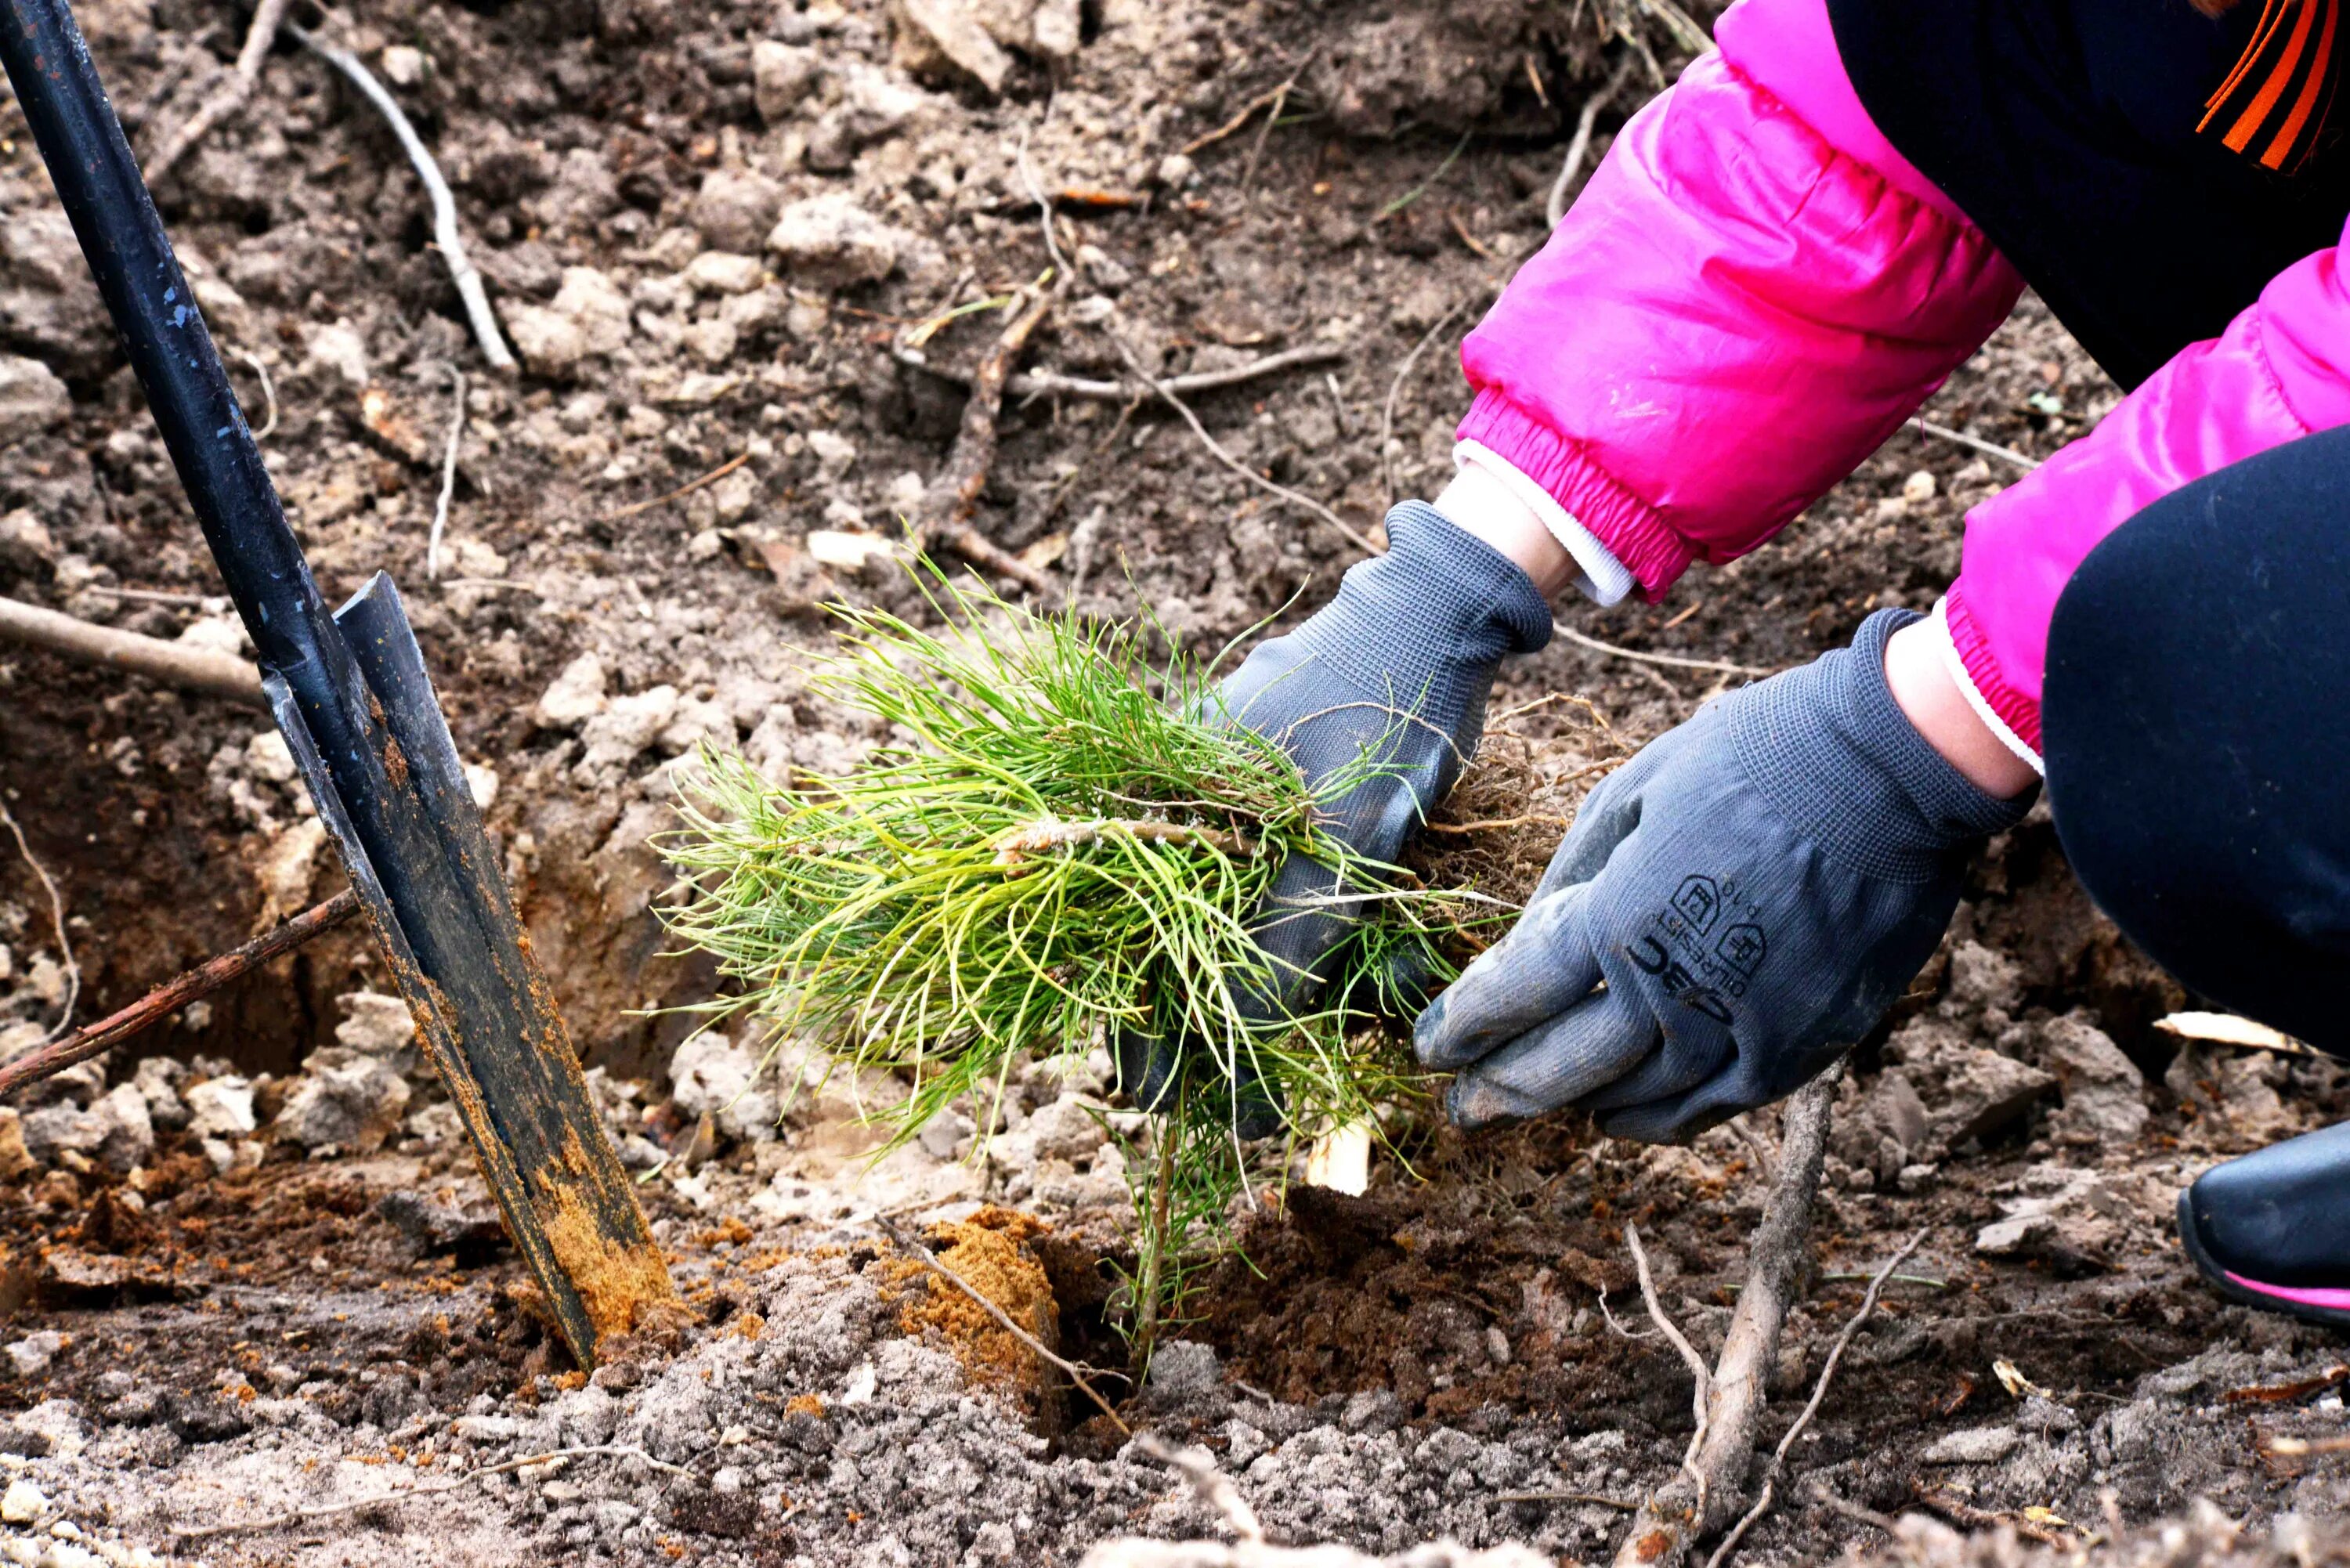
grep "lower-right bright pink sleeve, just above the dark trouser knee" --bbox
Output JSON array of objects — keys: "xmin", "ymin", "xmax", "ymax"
[{"xmin": 1943, "ymin": 230, "xmax": 2350, "ymax": 752}]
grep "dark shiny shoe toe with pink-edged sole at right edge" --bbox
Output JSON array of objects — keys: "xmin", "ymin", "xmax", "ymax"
[{"xmin": 2178, "ymin": 1122, "xmax": 2350, "ymax": 1328}]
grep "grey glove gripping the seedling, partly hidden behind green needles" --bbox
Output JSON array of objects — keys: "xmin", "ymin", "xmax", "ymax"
[{"xmin": 1116, "ymin": 500, "xmax": 1551, "ymax": 1136}]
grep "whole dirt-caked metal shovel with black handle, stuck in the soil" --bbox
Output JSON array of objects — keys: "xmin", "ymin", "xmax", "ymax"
[{"xmin": 0, "ymin": 0, "xmax": 677, "ymax": 1366}]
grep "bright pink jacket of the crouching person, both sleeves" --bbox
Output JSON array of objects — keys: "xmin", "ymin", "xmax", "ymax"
[{"xmin": 1459, "ymin": 0, "xmax": 2350, "ymax": 761}]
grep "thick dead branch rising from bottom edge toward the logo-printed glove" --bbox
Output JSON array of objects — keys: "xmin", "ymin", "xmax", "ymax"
[{"xmin": 1614, "ymin": 1068, "xmax": 1842, "ymax": 1568}]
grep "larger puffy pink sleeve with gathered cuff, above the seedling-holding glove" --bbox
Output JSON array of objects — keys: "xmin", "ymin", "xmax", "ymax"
[{"xmin": 1459, "ymin": 0, "xmax": 2023, "ymax": 599}]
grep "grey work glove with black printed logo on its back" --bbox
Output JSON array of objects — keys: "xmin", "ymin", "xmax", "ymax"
[{"xmin": 1412, "ymin": 611, "xmax": 2030, "ymax": 1143}]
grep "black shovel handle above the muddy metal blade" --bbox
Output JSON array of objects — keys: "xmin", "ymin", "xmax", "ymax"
[{"xmin": 0, "ymin": 0, "xmax": 348, "ymax": 712}]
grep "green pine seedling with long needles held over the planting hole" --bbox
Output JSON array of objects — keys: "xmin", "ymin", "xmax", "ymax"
[{"xmin": 665, "ymin": 585, "xmax": 1492, "ymax": 1354}]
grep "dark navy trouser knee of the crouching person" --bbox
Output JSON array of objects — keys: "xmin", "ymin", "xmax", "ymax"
[{"xmin": 2042, "ymin": 430, "xmax": 2350, "ymax": 1056}]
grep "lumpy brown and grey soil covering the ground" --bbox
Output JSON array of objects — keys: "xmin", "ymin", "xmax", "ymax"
[{"xmin": 0, "ymin": 0, "xmax": 2350, "ymax": 1566}]
